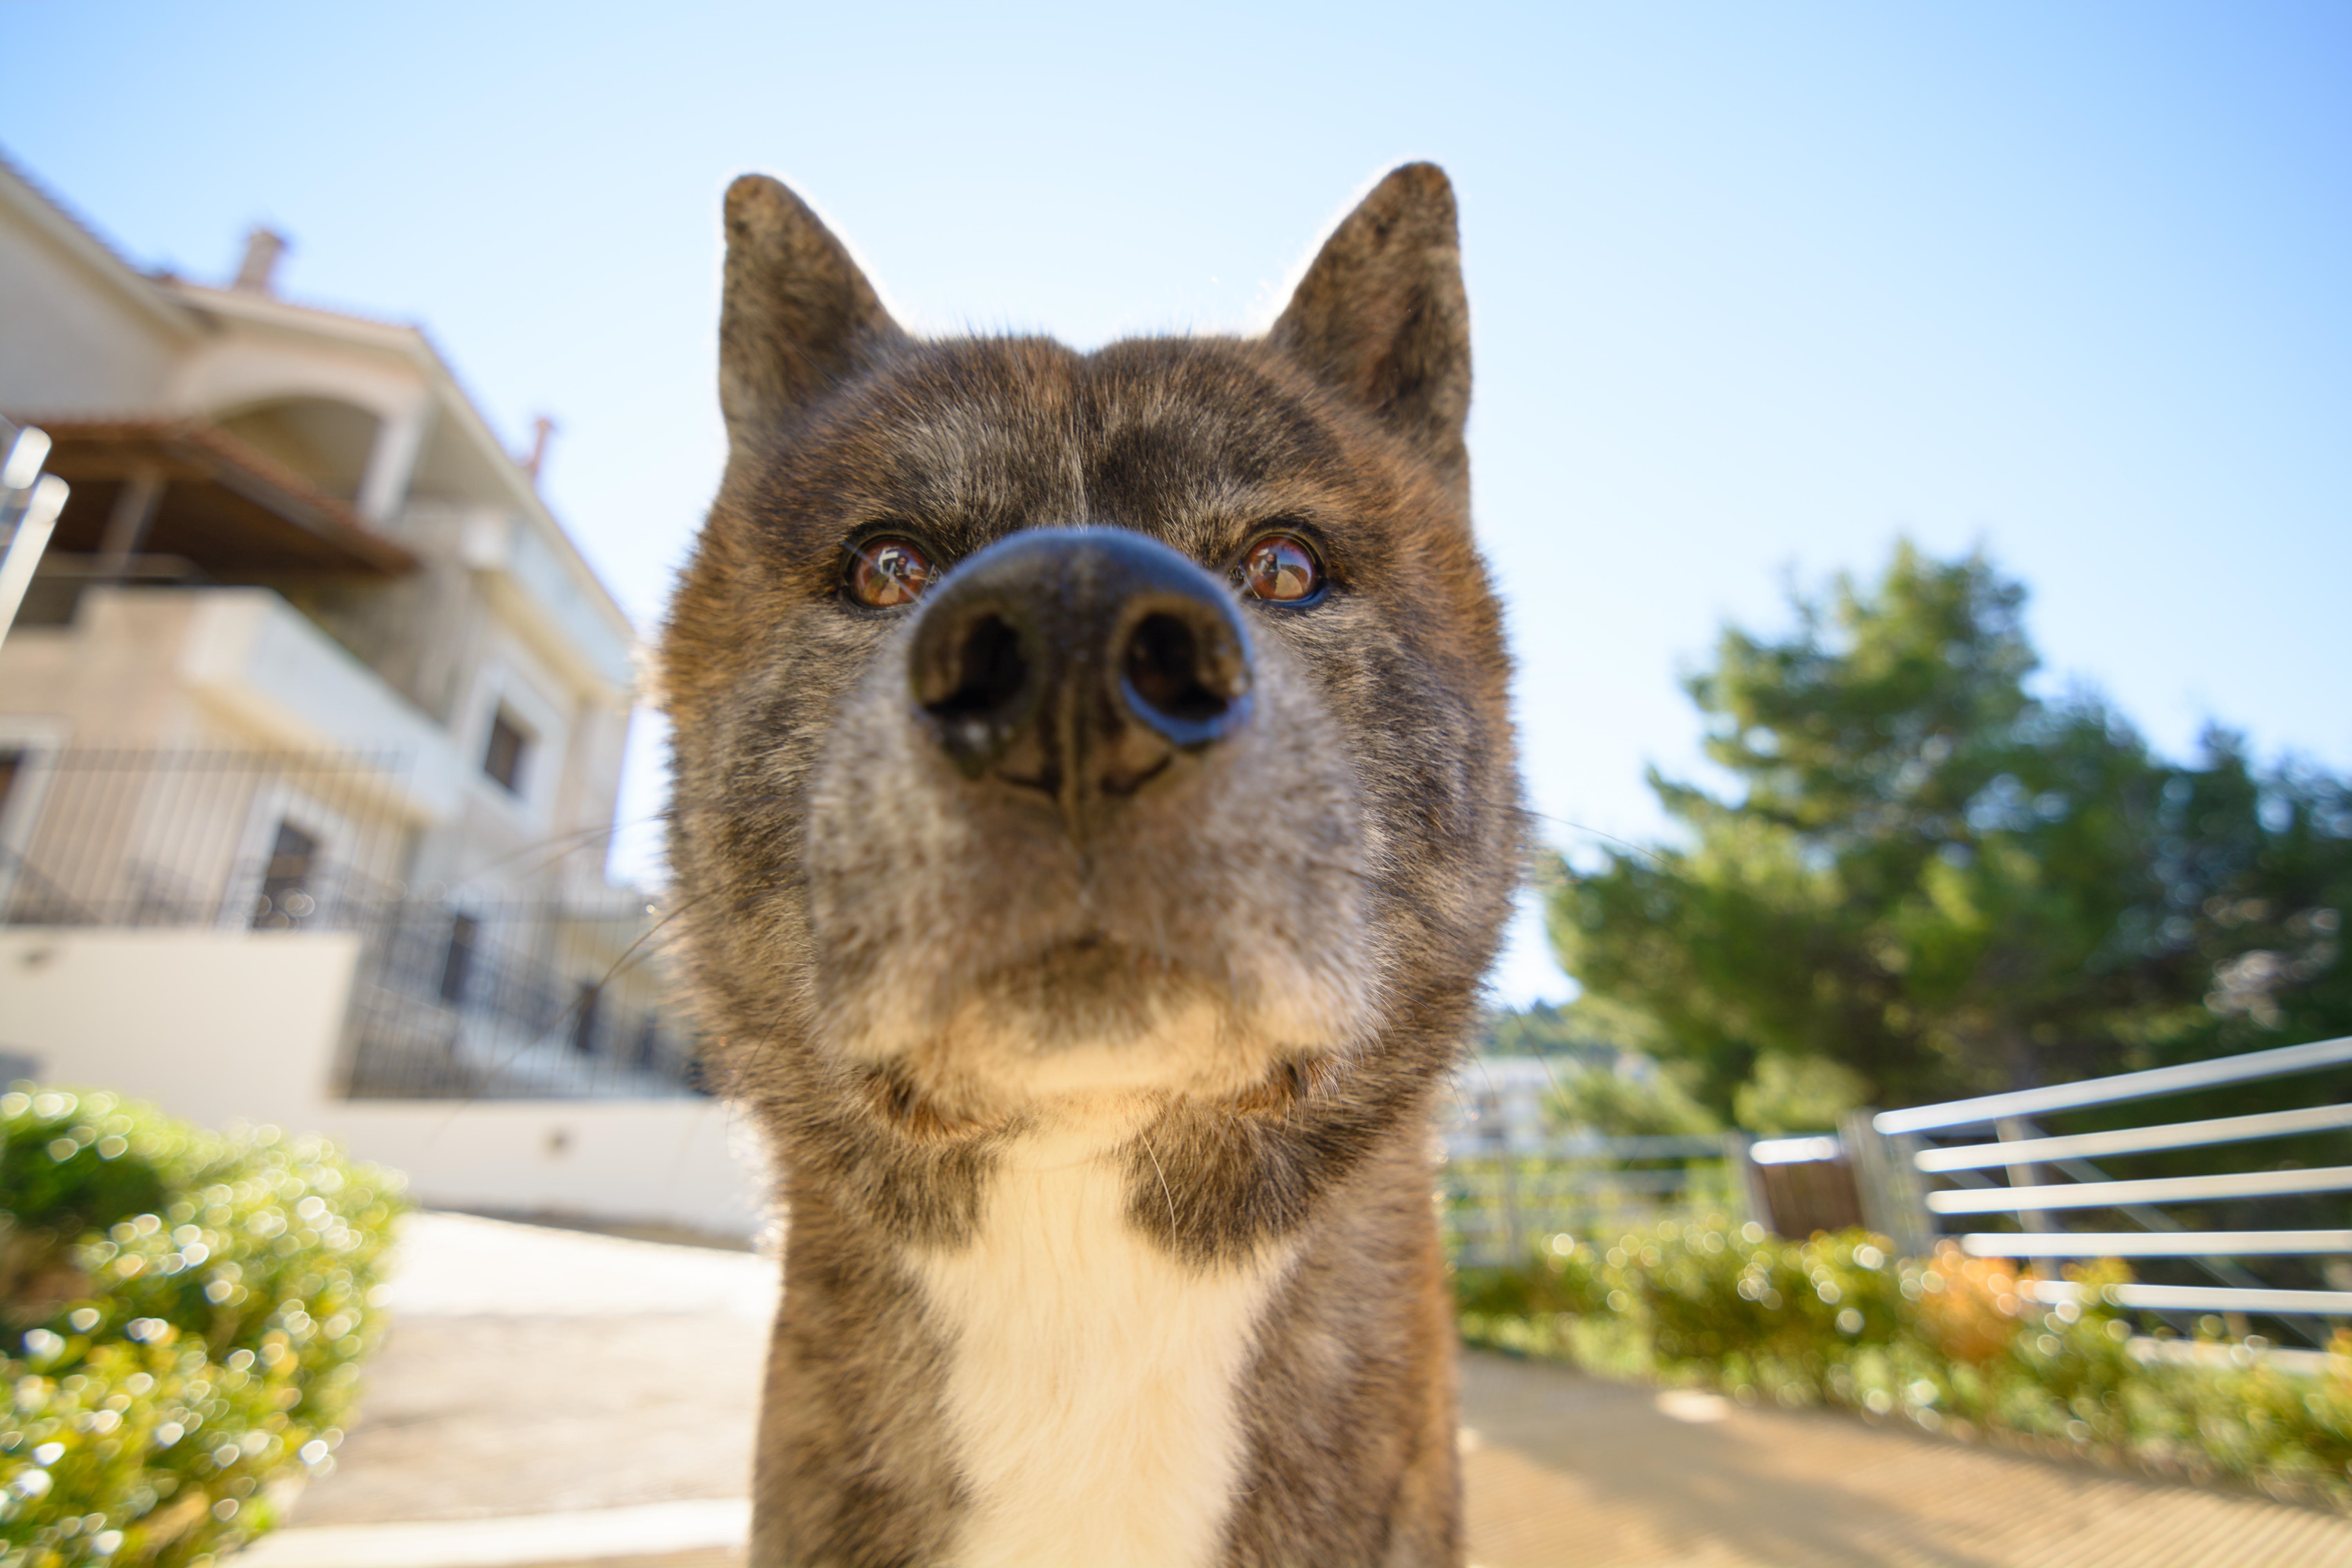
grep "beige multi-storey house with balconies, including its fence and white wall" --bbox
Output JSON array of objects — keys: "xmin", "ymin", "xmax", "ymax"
[{"xmin": 0, "ymin": 162, "xmax": 750, "ymax": 1225}]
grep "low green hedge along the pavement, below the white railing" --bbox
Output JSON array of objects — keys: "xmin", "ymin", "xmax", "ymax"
[{"xmin": 1454, "ymin": 1218, "xmax": 2352, "ymax": 1507}]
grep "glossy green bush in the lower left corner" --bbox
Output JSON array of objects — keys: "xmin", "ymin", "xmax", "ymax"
[{"xmin": 0, "ymin": 1086, "xmax": 405, "ymax": 1568}]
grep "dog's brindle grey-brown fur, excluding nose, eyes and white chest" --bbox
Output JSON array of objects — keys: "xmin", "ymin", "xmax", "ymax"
[{"xmin": 663, "ymin": 165, "xmax": 1519, "ymax": 1568}]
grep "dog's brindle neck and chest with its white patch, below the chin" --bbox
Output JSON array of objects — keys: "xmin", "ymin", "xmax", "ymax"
[{"xmin": 753, "ymin": 1002, "xmax": 1463, "ymax": 1568}]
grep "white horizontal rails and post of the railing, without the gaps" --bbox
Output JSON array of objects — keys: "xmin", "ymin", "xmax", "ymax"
[{"xmin": 1849, "ymin": 1039, "xmax": 2352, "ymax": 1342}]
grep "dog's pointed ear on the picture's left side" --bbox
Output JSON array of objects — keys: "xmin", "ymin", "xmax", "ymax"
[{"xmin": 720, "ymin": 174, "xmax": 906, "ymax": 444}]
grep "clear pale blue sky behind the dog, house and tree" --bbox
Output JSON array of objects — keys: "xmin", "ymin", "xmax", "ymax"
[{"xmin": 0, "ymin": 2, "xmax": 2352, "ymax": 999}]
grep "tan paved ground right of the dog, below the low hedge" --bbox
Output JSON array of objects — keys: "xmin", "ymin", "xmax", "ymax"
[{"xmin": 1463, "ymin": 1356, "xmax": 2352, "ymax": 1568}]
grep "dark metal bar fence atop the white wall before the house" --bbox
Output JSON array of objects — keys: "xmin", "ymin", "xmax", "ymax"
[{"xmin": 0, "ymin": 748, "xmax": 708, "ymax": 1100}]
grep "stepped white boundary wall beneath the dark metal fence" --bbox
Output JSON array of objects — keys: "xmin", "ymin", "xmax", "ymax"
[{"xmin": 0, "ymin": 926, "xmax": 767, "ymax": 1234}]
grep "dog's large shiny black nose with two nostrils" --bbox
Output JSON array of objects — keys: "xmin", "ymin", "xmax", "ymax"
[{"xmin": 908, "ymin": 529, "xmax": 1251, "ymax": 823}]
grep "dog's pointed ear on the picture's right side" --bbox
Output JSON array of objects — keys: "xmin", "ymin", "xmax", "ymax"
[{"xmin": 1268, "ymin": 162, "xmax": 1470, "ymax": 484}]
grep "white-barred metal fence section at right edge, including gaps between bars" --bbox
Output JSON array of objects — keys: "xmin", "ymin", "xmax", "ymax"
[{"xmin": 1846, "ymin": 1039, "xmax": 2352, "ymax": 1345}]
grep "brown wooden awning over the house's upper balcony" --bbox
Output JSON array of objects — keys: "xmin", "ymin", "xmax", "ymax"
[{"xmin": 24, "ymin": 418, "xmax": 416, "ymax": 581}]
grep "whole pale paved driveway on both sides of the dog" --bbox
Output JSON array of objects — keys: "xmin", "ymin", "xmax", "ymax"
[{"xmin": 240, "ymin": 1215, "xmax": 2352, "ymax": 1568}]
